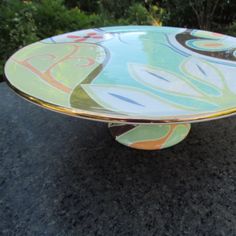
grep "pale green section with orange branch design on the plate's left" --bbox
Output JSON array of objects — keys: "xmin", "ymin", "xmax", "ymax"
[{"xmin": 5, "ymin": 43, "xmax": 106, "ymax": 107}]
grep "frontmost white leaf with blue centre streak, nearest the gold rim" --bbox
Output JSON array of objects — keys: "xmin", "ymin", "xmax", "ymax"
[{"xmin": 78, "ymin": 84, "xmax": 194, "ymax": 117}]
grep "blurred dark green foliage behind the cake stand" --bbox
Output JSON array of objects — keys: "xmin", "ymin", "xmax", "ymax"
[{"xmin": 0, "ymin": 0, "xmax": 236, "ymax": 79}]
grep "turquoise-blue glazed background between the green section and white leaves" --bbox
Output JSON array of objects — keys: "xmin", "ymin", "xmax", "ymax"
[{"xmin": 93, "ymin": 27, "xmax": 218, "ymax": 111}]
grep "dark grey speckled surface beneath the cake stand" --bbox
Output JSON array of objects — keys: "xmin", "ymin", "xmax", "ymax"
[{"xmin": 0, "ymin": 83, "xmax": 236, "ymax": 236}]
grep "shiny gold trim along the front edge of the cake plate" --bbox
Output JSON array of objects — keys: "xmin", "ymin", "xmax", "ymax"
[{"xmin": 5, "ymin": 78, "xmax": 236, "ymax": 124}]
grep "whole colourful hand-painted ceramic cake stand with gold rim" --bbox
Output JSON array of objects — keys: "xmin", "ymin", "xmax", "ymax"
[{"xmin": 5, "ymin": 26, "xmax": 236, "ymax": 150}]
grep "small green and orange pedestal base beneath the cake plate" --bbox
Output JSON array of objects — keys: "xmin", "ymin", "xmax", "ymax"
[{"xmin": 108, "ymin": 123, "xmax": 191, "ymax": 150}]
